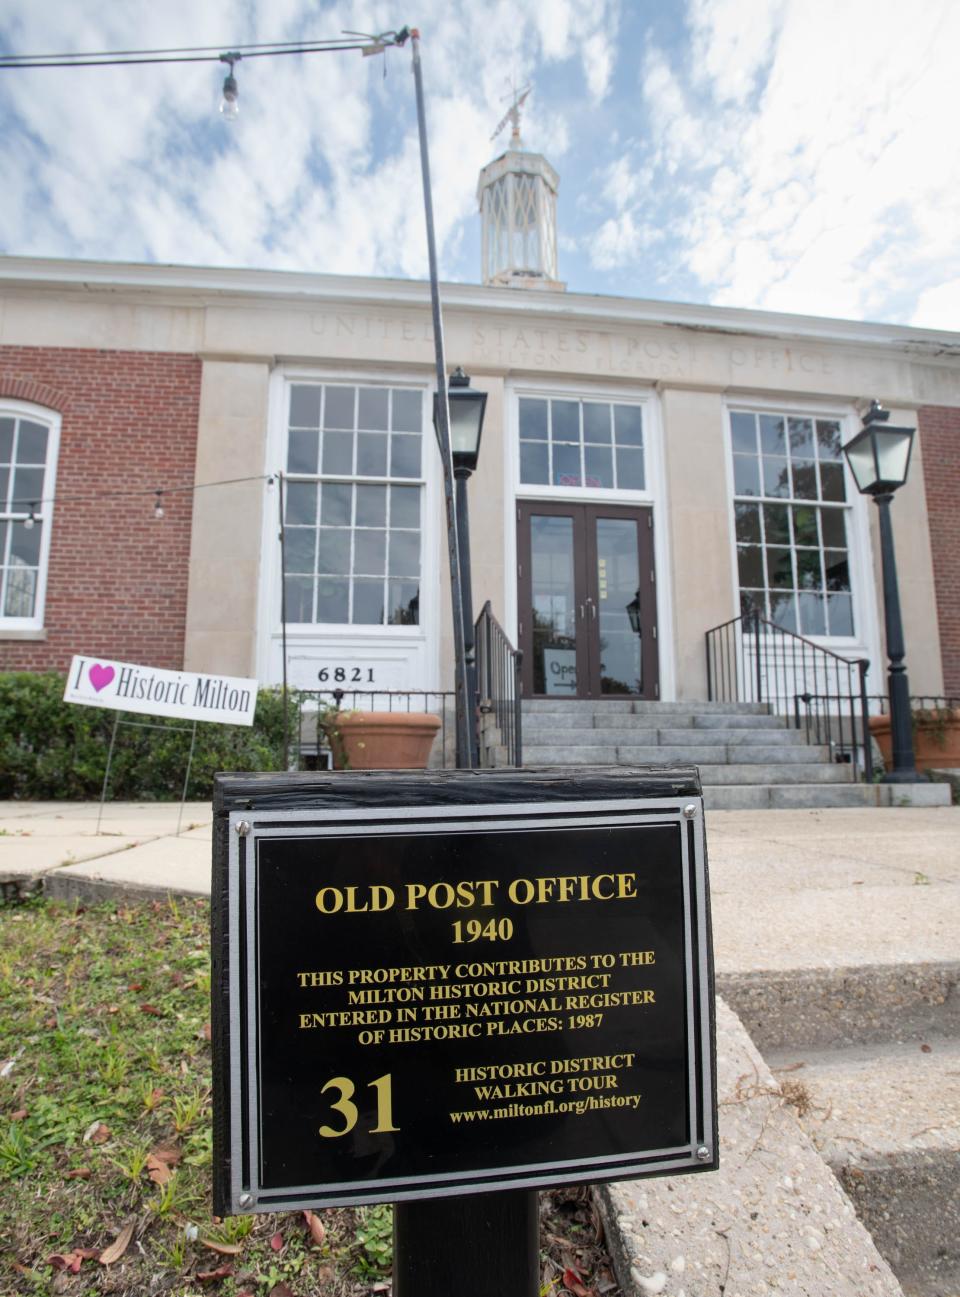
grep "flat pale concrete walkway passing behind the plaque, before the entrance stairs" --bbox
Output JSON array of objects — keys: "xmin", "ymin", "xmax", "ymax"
[{"xmin": 0, "ymin": 802, "xmax": 960, "ymax": 974}]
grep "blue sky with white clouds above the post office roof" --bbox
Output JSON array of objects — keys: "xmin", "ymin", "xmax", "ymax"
[{"xmin": 0, "ymin": 0, "xmax": 960, "ymax": 329}]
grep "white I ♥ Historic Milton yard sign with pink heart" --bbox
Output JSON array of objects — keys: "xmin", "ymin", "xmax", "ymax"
[{"xmin": 64, "ymin": 656, "xmax": 257, "ymax": 725}]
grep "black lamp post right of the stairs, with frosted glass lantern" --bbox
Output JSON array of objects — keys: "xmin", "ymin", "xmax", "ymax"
[{"xmin": 843, "ymin": 401, "xmax": 920, "ymax": 783}]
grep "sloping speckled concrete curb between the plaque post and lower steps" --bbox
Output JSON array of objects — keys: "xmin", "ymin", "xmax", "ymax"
[{"xmin": 598, "ymin": 1001, "xmax": 903, "ymax": 1297}]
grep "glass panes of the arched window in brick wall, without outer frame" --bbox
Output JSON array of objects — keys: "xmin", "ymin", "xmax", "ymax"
[{"xmin": 0, "ymin": 411, "xmax": 51, "ymax": 624}]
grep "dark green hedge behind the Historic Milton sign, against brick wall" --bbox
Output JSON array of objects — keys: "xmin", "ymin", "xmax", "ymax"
[{"xmin": 0, "ymin": 672, "xmax": 297, "ymax": 802}]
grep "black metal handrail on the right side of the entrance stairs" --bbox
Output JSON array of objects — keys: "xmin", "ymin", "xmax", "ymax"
[{"xmin": 706, "ymin": 613, "xmax": 873, "ymax": 782}]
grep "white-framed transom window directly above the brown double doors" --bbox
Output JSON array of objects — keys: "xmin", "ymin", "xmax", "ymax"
[{"xmin": 520, "ymin": 397, "xmax": 645, "ymax": 490}]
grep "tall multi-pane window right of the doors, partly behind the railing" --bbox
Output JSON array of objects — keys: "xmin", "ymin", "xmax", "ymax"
[{"xmin": 730, "ymin": 410, "xmax": 854, "ymax": 636}]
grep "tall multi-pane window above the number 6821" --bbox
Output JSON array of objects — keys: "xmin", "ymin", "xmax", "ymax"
[{"xmin": 284, "ymin": 384, "xmax": 423, "ymax": 626}]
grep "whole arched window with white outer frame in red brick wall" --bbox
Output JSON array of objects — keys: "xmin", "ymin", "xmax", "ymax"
[{"xmin": 0, "ymin": 401, "xmax": 60, "ymax": 637}]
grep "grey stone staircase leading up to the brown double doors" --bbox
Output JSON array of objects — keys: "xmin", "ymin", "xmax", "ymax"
[{"xmin": 523, "ymin": 698, "xmax": 950, "ymax": 811}]
